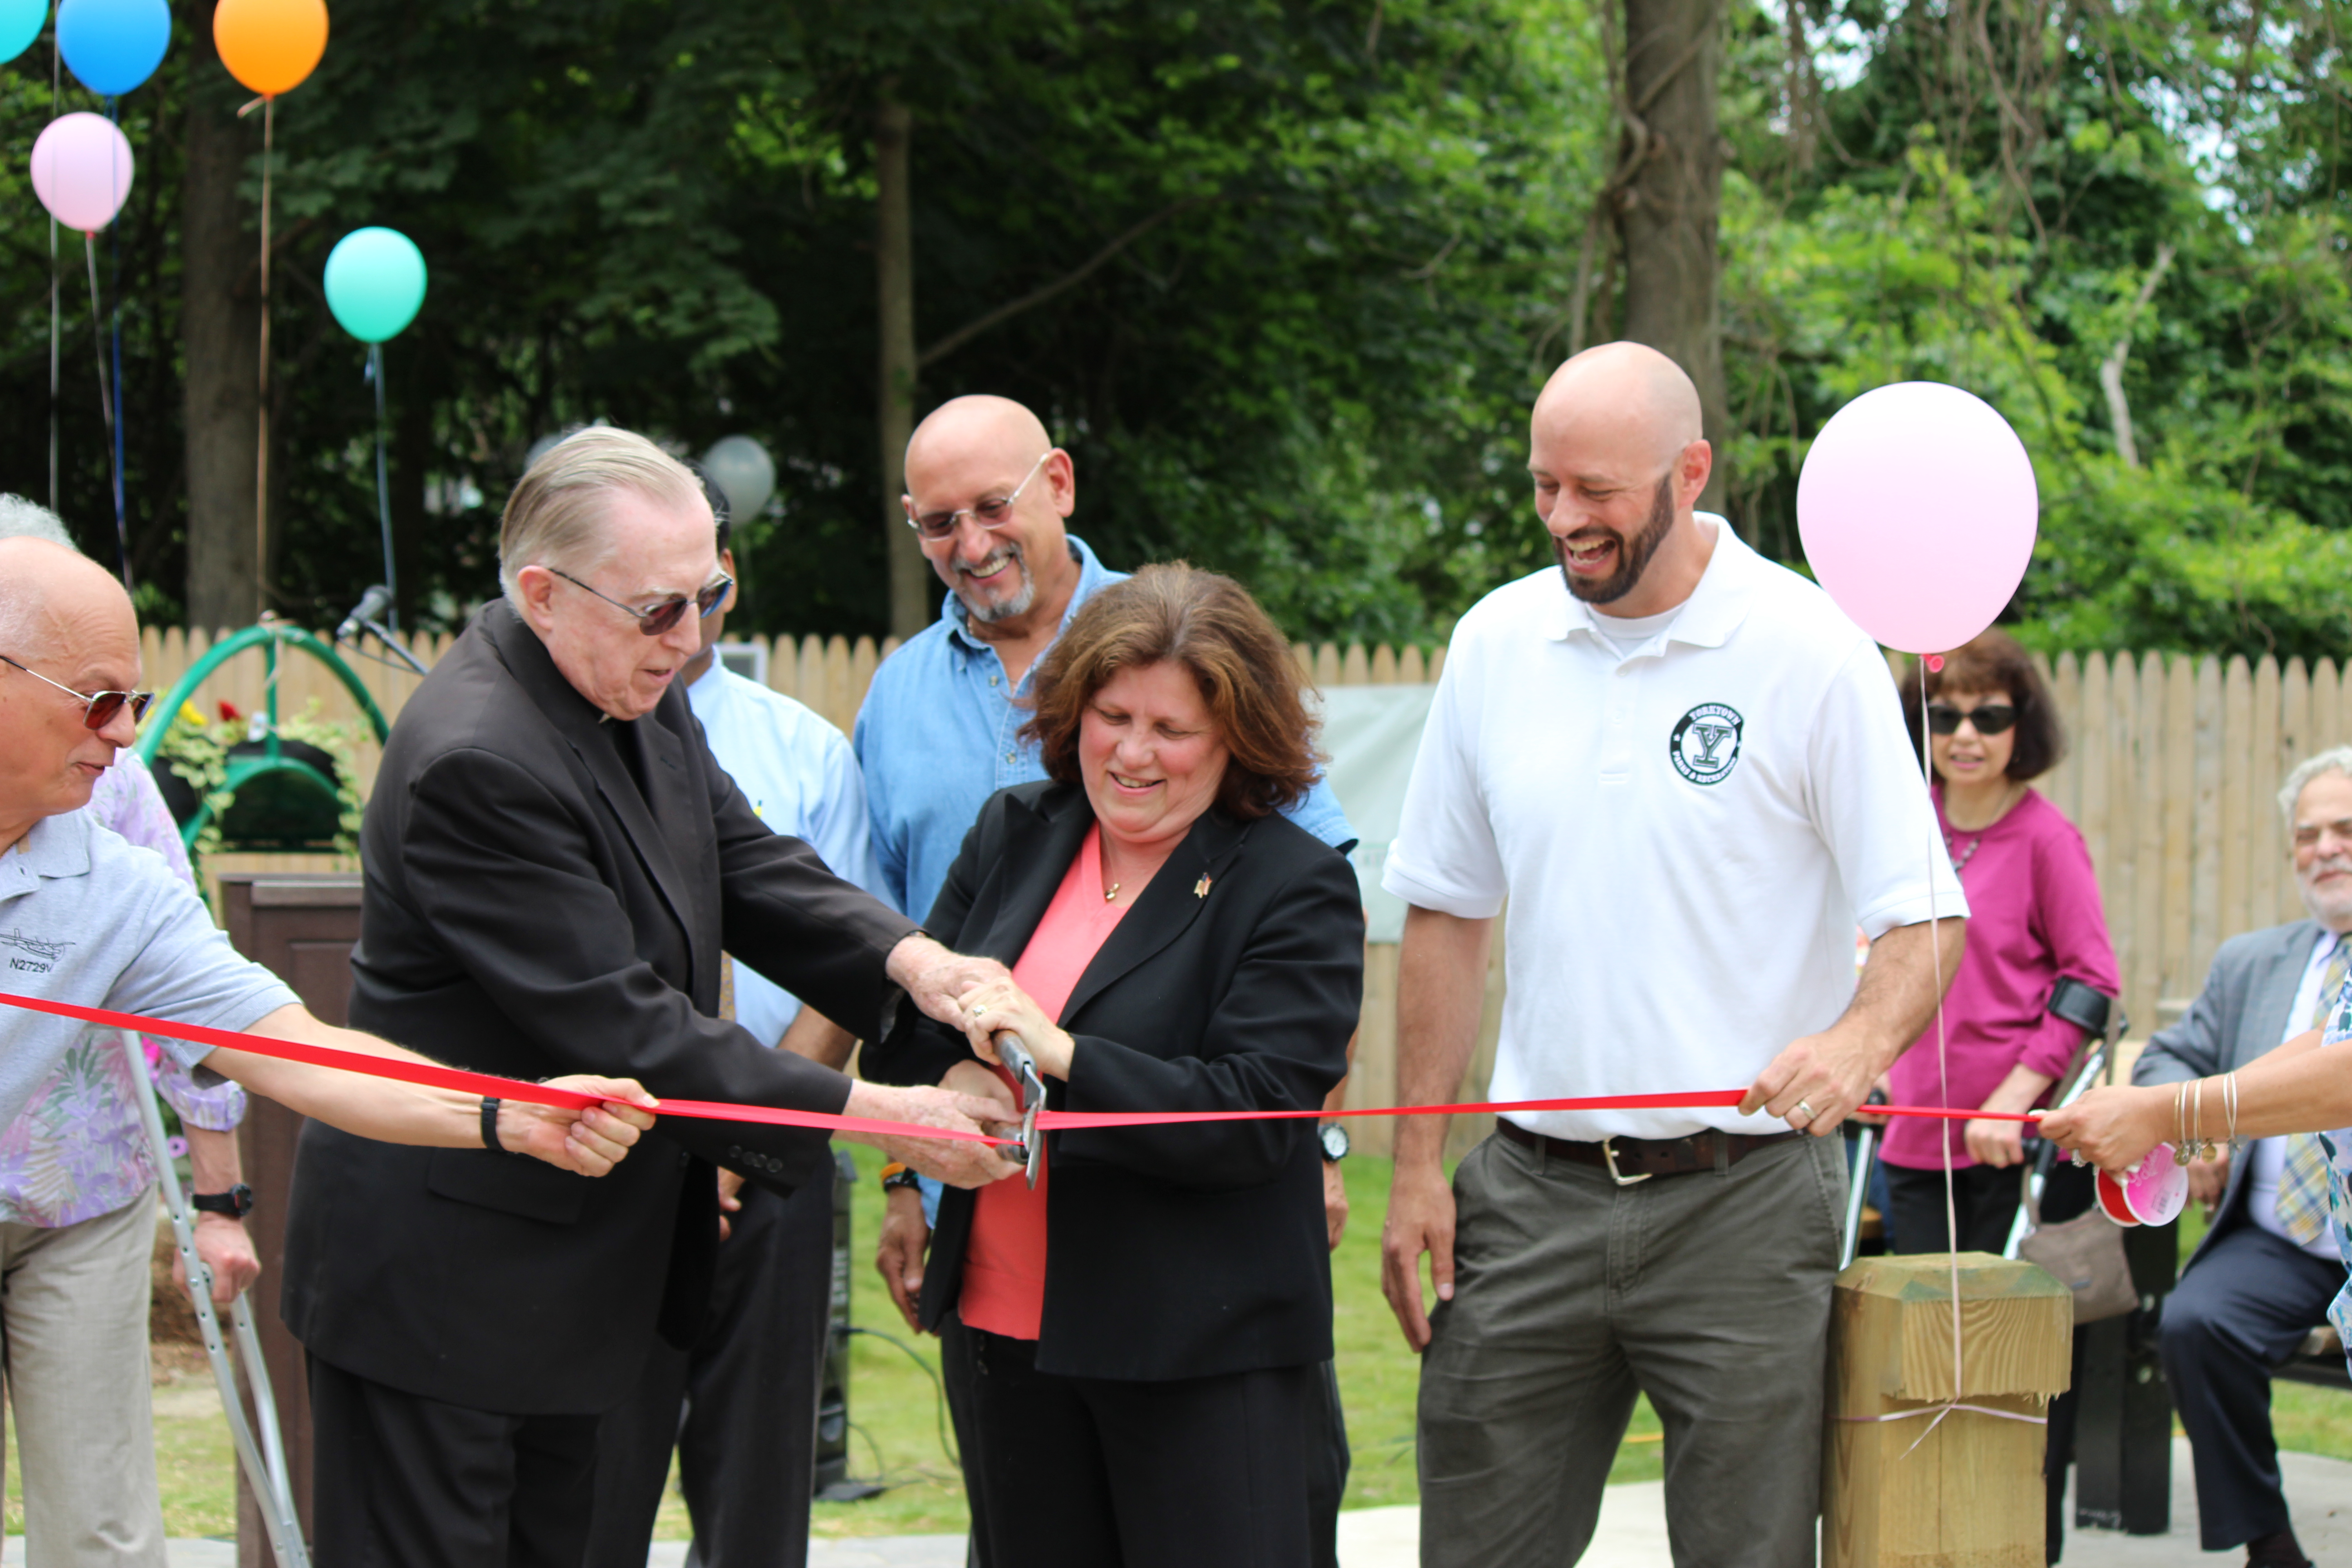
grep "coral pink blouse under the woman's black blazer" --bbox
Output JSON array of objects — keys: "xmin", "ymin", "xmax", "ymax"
[{"xmin": 955, "ymin": 828, "xmax": 1132, "ymax": 1340}]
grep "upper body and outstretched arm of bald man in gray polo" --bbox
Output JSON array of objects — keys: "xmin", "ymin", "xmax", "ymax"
[{"xmin": 0, "ymin": 539, "xmax": 654, "ymax": 1176}]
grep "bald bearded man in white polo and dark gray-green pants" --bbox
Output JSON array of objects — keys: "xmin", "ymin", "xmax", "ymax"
[{"xmin": 1381, "ymin": 343, "xmax": 1966, "ymax": 1568}]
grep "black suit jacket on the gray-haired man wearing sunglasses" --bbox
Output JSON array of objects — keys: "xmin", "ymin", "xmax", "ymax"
[{"xmin": 282, "ymin": 599, "xmax": 915, "ymax": 1415}]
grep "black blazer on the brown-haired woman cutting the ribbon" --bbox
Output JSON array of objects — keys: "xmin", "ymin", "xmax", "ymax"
[{"xmin": 863, "ymin": 783, "xmax": 1364, "ymax": 1380}]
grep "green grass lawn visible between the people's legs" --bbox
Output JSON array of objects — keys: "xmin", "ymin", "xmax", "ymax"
[{"xmin": 137, "ymin": 1147, "xmax": 2352, "ymax": 1540}]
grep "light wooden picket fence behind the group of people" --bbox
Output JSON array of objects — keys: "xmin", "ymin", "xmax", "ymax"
[{"xmin": 143, "ymin": 627, "xmax": 2352, "ymax": 1142}]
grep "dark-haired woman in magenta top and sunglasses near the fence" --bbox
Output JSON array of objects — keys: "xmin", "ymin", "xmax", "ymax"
[{"xmin": 1884, "ymin": 630, "xmax": 2119, "ymax": 1253}]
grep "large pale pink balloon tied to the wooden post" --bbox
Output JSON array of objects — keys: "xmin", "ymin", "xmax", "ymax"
[{"xmin": 1797, "ymin": 381, "xmax": 2042, "ymax": 653}]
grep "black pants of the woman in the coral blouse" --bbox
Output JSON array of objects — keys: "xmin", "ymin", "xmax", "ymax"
[{"xmin": 962, "ymin": 1328, "xmax": 1322, "ymax": 1568}]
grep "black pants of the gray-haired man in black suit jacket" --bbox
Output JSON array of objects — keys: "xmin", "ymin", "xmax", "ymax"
[{"xmin": 308, "ymin": 1357, "xmax": 602, "ymax": 1568}]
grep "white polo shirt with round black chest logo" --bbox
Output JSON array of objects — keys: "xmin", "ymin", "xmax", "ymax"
[{"xmin": 1381, "ymin": 513, "xmax": 1966, "ymax": 1138}]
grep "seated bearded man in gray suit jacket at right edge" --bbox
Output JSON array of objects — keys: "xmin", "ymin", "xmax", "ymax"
[{"xmin": 2131, "ymin": 748, "xmax": 2352, "ymax": 1568}]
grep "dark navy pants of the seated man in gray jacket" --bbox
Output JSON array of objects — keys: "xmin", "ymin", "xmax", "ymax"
[{"xmin": 2159, "ymin": 1220, "xmax": 2345, "ymax": 1552}]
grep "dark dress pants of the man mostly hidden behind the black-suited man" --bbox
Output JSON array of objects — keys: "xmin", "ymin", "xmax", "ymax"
[{"xmin": 578, "ymin": 1159, "xmax": 833, "ymax": 1568}]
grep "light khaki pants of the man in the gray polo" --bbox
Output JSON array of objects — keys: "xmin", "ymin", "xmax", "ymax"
[{"xmin": 0, "ymin": 1187, "xmax": 165, "ymax": 1568}]
